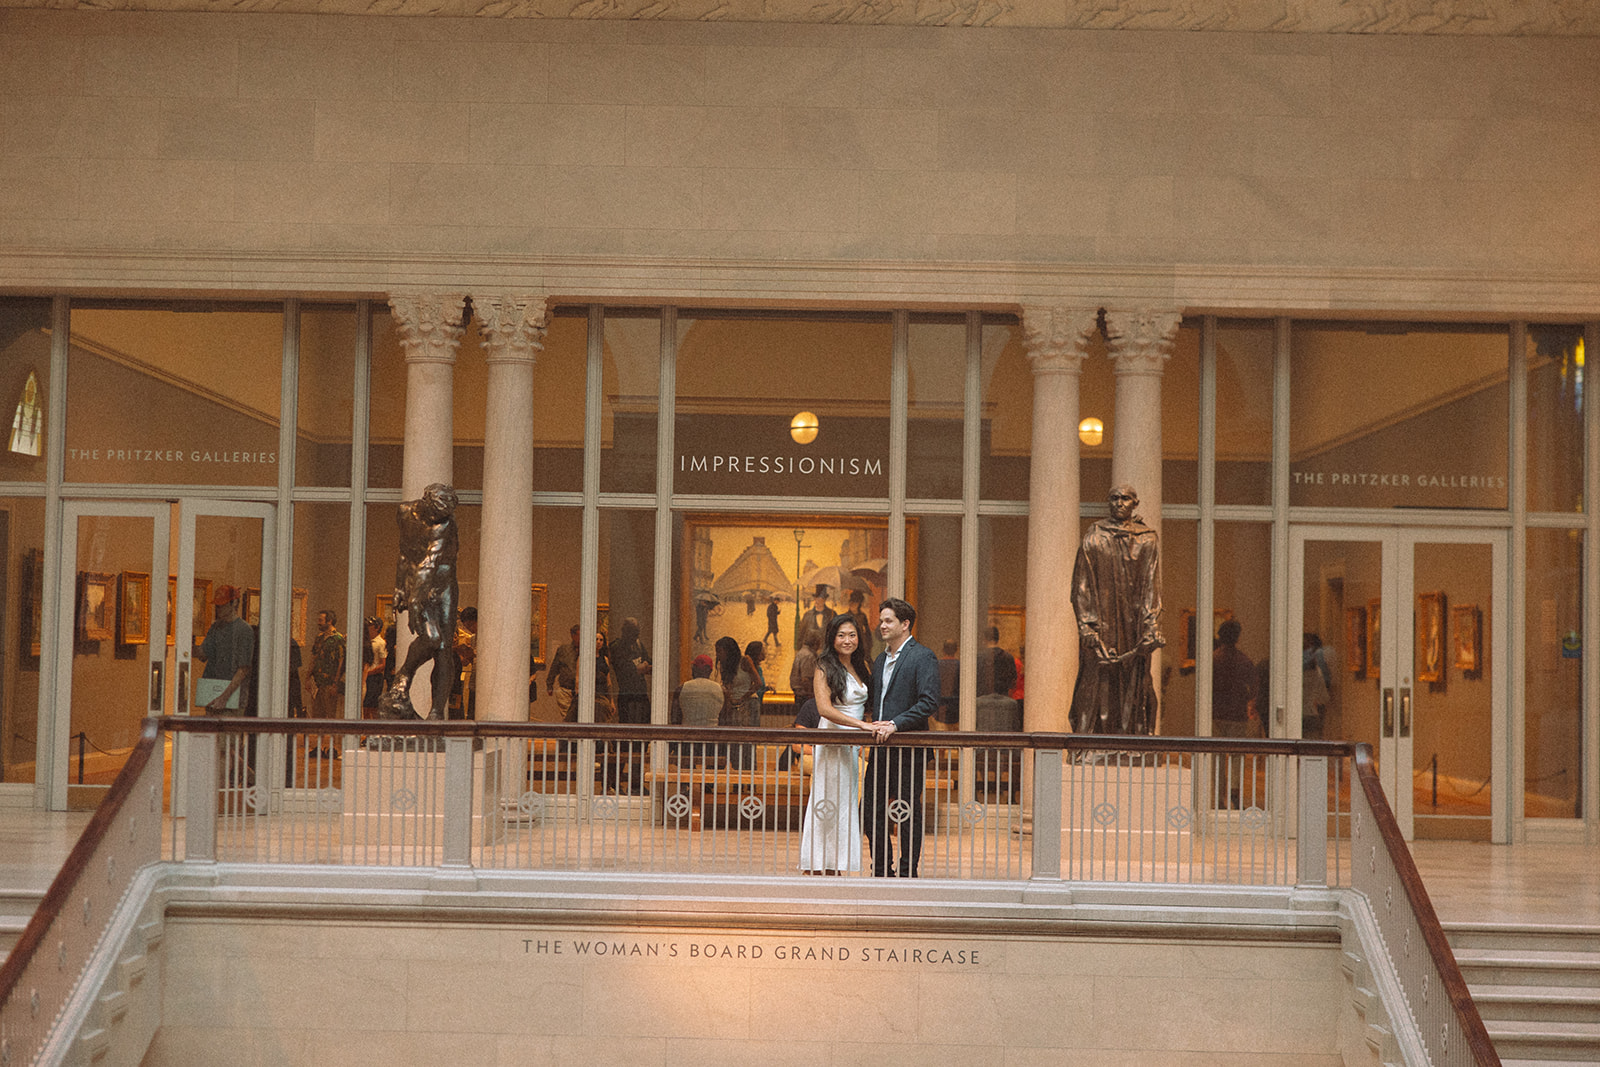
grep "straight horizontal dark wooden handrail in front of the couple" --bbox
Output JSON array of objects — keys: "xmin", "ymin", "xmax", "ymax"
[{"xmin": 152, "ymin": 715, "xmax": 1354, "ymax": 758}]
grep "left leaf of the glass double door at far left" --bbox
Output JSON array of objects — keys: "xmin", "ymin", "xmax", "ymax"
[{"xmin": 50, "ymin": 501, "xmax": 170, "ymax": 809}]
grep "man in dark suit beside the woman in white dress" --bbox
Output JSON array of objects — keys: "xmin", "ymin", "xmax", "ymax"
[{"xmin": 861, "ymin": 597, "xmax": 939, "ymax": 878}]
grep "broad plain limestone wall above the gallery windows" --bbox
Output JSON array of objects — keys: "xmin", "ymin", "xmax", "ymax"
[{"xmin": 0, "ymin": 10, "xmax": 1600, "ymax": 312}]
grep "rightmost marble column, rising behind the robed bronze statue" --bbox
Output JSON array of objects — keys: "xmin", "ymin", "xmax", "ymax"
[{"xmin": 1106, "ymin": 309, "xmax": 1182, "ymax": 533}]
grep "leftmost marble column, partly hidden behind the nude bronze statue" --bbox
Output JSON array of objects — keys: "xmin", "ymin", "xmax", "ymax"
[{"xmin": 385, "ymin": 291, "xmax": 467, "ymax": 717}]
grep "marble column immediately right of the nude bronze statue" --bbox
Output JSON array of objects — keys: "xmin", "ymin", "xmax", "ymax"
[{"xmin": 472, "ymin": 293, "xmax": 546, "ymax": 721}]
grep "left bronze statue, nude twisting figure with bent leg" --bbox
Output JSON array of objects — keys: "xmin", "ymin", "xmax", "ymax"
[{"xmin": 379, "ymin": 483, "xmax": 461, "ymax": 718}]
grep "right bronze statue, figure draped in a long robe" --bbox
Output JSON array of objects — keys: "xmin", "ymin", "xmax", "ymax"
[{"xmin": 1072, "ymin": 485, "xmax": 1166, "ymax": 734}]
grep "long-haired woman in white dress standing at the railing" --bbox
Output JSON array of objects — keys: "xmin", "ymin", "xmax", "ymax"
[{"xmin": 800, "ymin": 614, "xmax": 870, "ymax": 875}]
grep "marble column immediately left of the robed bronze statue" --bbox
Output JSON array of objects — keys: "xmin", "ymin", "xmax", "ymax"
[{"xmin": 1022, "ymin": 307, "xmax": 1099, "ymax": 733}]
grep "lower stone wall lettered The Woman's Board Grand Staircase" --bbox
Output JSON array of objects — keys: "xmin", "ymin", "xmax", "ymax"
[{"xmin": 144, "ymin": 915, "xmax": 1349, "ymax": 1067}]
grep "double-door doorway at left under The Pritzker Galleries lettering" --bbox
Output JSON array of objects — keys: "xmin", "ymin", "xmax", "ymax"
[{"xmin": 48, "ymin": 499, "xmax": 274, "ymax": 809}]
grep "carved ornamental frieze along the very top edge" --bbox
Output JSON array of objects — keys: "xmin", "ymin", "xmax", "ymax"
[{"xmin": 0, "ymin": 0, "xmax": 1600, "ymax": 37}]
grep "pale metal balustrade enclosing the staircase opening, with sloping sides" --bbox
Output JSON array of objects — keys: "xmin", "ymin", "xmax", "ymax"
[{"xmin": 0, "ymin": 717, "xmax": 1499, "ymax": 1067}]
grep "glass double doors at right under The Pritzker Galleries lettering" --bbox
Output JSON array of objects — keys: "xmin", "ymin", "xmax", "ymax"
[{"xmin": 1288, "ymin": 526, "xmax": 1510, "ymax": 841}]
